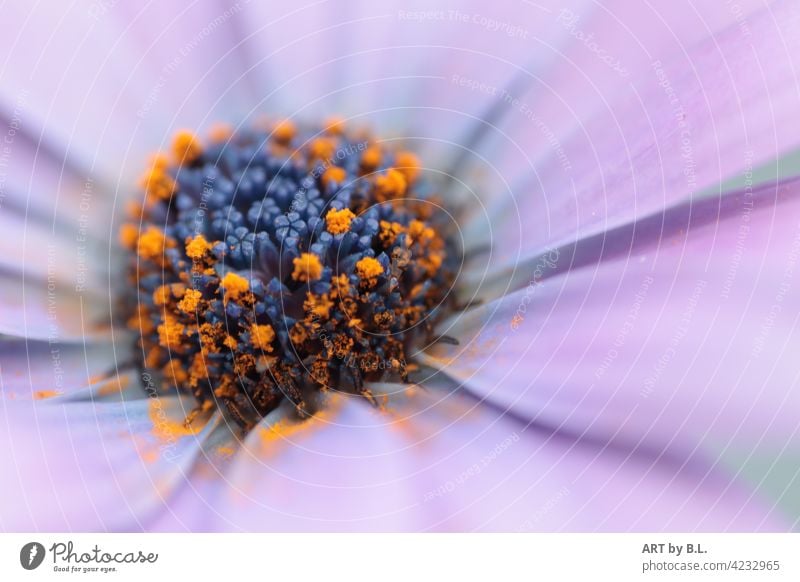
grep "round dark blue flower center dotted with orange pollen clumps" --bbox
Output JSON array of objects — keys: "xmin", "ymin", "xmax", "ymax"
[{"xmin": 120, "ymin": 121, "xmax": 460, "ymax": 428}]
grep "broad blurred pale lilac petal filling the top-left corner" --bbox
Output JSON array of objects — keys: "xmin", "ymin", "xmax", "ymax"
[{"xmin": 0, "ymin": 0, "xmax": 253, "ymax": 187}]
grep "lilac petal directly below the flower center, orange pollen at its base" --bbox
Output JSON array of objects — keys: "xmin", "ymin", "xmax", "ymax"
[{"xmin": 193, "ymin": 398, "xmax": 432, "ymax": 531}]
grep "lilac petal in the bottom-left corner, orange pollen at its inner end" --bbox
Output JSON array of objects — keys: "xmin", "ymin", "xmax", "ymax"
[{"xmin": 0, "ymin": 397, "xmax": 216, "ymax": 531}]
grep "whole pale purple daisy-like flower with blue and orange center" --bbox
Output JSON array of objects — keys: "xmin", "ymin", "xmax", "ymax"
[{"xmin": 0, "ymin": 2, "xmax": 800, "ymax": 531}]
